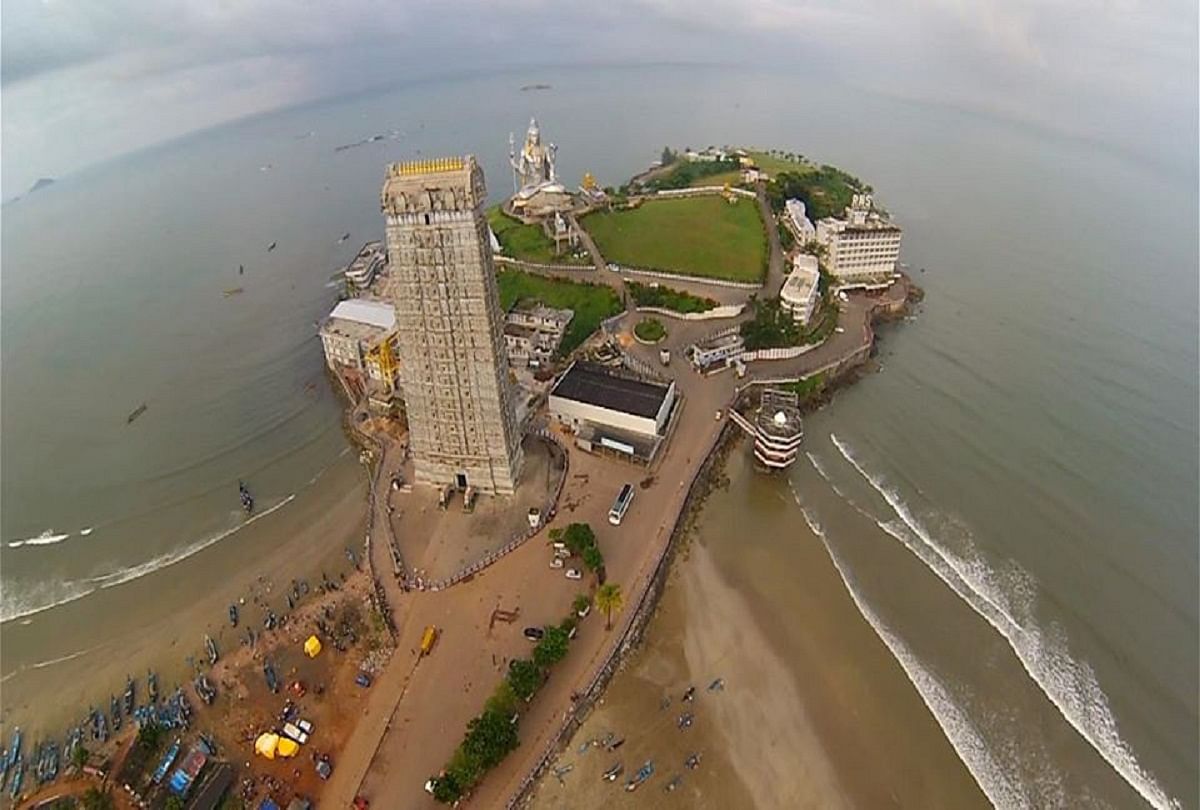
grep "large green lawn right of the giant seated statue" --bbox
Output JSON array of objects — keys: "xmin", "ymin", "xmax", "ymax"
[{"xmin": 583, "ymin": 194, "xmax": 767, "ymax": 282}]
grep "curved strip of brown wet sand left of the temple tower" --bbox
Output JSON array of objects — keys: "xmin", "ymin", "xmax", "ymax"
[{"xmin": 0, "ymin": 454, "xmax": 366, "ymax": 739}]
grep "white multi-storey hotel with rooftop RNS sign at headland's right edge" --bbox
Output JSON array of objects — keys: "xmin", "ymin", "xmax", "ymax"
[{"xmin": 817, "ymin": 194, "xmax": 901, "ymax": 287}]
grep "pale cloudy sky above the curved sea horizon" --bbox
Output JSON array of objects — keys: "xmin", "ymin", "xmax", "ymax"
[{"xmin": 0, "ymin": 0, "xmax": 1200, "ymax": 198}]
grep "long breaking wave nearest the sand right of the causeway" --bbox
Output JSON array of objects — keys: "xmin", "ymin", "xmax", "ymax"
[{"xmin": 793, "ymin": 504, "xmax": 1033, "ymax": 808}]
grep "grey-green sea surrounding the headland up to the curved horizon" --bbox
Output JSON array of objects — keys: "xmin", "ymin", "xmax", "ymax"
[{"xmin": 0, "ymin": 66, "xmax": 1200, "ymax": 808}]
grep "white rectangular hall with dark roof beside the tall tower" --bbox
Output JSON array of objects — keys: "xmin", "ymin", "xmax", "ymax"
[{"xmin": 550, "ymin": 362, "xmax": 676, "ymax": 457}]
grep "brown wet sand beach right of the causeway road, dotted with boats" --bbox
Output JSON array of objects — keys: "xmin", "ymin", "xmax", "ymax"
[{"xmin": 533, "ymin": 444, "xmax": 988, "ymax": 808}]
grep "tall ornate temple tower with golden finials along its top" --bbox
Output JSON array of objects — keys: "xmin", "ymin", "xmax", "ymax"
[{"xmin": 380, "ymin": 156, "xmax": 523, "ymax": 494}]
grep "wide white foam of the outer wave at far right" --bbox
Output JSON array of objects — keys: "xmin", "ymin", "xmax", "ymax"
[{"xmin": 829, "ymin": 433, "xmax": 1180, "ymax": 810}]
